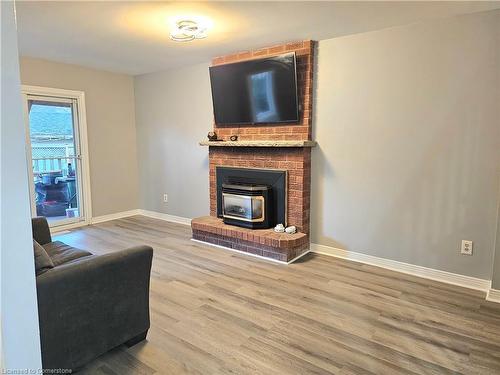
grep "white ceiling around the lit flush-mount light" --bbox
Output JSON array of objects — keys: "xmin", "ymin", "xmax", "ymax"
[{"xmin": 16, "ymin": 1, "xmax": 500, "ymax": 75}]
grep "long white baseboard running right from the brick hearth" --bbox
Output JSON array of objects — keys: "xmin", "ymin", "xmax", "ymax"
[{"xmin": 311, "ymin": 243, "xmax": 491, "ymax": 292}]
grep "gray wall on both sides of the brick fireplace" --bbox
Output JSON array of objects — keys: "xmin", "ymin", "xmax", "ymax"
[{"xmin": 135, "ymin": 11, "xmax": 500, "ymax": 279}]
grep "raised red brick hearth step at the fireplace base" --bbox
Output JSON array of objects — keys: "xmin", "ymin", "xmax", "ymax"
[{"xmin": 191, "ymin": 216, "xmax": 309, "ymax": 262}]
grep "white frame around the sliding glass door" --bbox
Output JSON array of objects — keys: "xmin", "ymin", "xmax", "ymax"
[{"xmin": 21, "ymin": 85, "xmax": 92, "ymax": 232}]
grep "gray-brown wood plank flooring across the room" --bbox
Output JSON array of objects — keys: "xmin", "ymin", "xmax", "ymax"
[{"xmin": 56, "ymin": 216, "xmax": 500, "ymax": 375}]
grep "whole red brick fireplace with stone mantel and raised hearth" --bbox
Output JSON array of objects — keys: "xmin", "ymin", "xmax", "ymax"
[{"xmin": 191, "ymin": 41, "xmax": 315, "ymax": 262}]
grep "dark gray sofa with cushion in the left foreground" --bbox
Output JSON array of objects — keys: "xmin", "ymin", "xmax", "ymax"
[{"xmin": 32, "ymin": 218, "xmax": 153, "ymax": 370}]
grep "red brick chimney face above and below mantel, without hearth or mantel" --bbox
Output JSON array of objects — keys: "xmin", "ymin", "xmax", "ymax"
[{"xmin": 209, "ymin": 40, "xmax": 314, "ymax": 234}]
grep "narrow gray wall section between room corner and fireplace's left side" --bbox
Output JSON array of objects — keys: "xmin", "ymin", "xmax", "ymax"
[{"xmin": 135, "ymin": 64, "xmax": 212, "ymax": 218}]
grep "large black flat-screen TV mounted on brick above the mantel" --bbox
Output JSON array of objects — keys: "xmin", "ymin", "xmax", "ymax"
[{"xmin": 210, "ymin": 53, "xmax": 299, "ymax": 125}]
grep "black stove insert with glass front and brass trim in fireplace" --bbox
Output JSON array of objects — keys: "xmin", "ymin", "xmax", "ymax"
[{"xmin": 222, "ymin": 184, "xmax": 273, "ymax": 229}]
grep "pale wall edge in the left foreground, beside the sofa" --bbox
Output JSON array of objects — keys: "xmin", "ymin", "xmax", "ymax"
[{"xmin": 0, "ymin": 1, "xmax": 41, "ymax": 370}]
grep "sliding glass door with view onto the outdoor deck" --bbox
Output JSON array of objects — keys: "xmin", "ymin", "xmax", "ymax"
[{"xmin": 24, "ymin": 91, "xmax": 88, "ymax": 226}]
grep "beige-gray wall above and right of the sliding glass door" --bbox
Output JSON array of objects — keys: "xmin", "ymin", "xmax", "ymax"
[{"xmin": 21, "ymin": 57, "xmax": 139, "ymax": 217}]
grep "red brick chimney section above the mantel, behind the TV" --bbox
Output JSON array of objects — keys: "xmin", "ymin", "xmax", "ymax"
[{"xmin": 212, "ymin": 40, "xmax": 314, "ymax": 141}]
